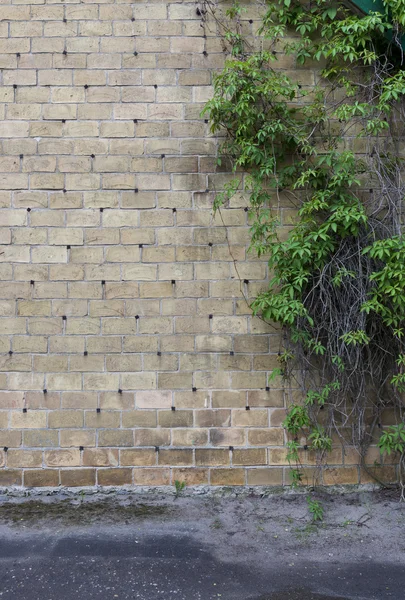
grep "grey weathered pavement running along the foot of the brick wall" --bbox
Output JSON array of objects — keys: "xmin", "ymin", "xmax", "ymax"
[{"xmin": 0, "ymin": 491, "xmax": 405, "ymax": 600}]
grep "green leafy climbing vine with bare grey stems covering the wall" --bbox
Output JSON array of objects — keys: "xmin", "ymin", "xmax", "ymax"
[{"xmin": 198, "ymin": 0, "xmax": 405, "ymax": 496}]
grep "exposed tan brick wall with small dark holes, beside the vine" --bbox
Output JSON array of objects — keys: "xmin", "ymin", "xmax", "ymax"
[{"xmin": 0, "ymin": 0, "xmax": 384, "ymax": 486}]
